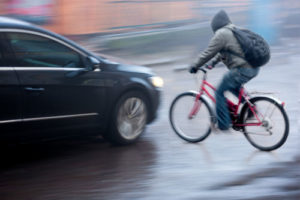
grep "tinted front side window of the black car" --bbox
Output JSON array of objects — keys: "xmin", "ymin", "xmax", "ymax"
[{"xmin": 7, "ymin": 33, "xmax": 83, "ymax": 68}]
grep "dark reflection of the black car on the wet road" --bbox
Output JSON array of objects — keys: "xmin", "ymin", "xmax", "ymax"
[{"xmin": 0, "ymin": 138, "xmax": 156, "ymax": 200}]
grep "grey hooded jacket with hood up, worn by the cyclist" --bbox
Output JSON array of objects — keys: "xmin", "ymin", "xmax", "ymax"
[{"xmin": 195, "ymin": 10, "xmax": 251, "ymax": 69}]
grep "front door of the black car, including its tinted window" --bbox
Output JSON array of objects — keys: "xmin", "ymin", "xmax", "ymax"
[{"xmin": 6, "ymin": 32, "xmax": 105, "ymax": 134}]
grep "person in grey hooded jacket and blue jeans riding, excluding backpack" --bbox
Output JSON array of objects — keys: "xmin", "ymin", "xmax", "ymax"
[{"xmin": 190, "ymin": 10, "xmax": 259, "ymax": 130}]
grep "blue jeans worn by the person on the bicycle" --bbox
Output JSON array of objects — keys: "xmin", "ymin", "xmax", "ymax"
[{"xmin": 216, "ymin": 67, "xmax": 259, "ymax": 130}]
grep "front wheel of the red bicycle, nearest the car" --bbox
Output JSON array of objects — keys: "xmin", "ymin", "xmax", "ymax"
[{"xmin": 169, "ymin": 92, "xmax": 213, "ymax": 142}]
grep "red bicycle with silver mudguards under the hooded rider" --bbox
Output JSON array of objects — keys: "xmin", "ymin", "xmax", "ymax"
[{"xmin": 169, "ymin": 68, "xmax": 289, "ymax": 151}]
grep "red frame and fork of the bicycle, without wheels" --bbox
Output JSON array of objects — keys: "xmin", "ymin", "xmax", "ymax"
[{"xmin": 189, "ymin": 69, "xmax": 262, "ymax": 127}]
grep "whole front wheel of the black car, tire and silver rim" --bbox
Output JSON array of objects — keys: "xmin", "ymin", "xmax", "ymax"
[{"xmin": 105, "ymin": 91, "xmax": 148, "ymax": 145}]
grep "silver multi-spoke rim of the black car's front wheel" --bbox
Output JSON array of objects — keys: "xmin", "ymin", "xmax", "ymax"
[{"xmin": 117, "ymin": 97, "xmax": 147, "ymax": 140}]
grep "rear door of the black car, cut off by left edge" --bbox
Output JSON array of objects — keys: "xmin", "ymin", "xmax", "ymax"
[{"xmin": 0, "ymin": 33, "xmax": 22, "ymax": 135}]
